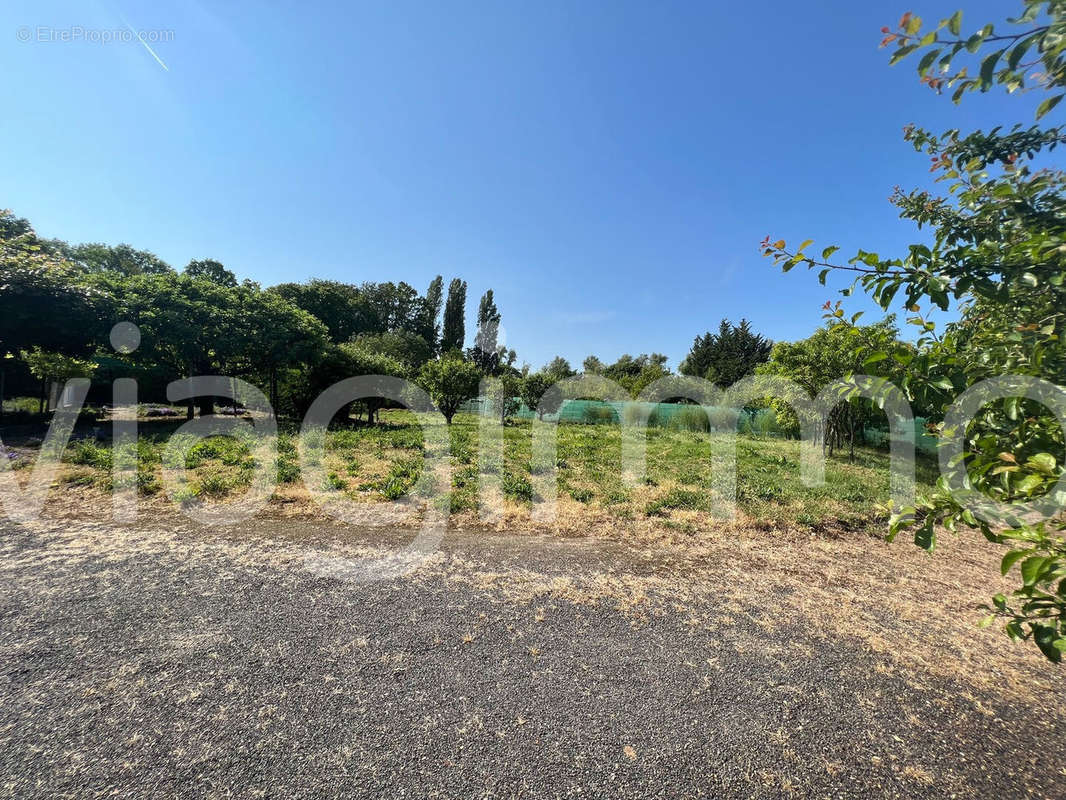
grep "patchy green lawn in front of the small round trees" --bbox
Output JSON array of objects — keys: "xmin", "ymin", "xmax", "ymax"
[{"xmin": 5, "ymin": 411, "xmax": 935, "ymax": 531}]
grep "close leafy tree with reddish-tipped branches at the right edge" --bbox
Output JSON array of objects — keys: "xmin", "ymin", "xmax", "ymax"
[{"xmin": 762, "ymin": 0, "xmax": 1066, "ymax": 661}]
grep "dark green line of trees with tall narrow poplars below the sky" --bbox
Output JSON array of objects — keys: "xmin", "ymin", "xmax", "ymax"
[{"xmin": 8, "ymin": 211, "xmax": 895, "ymax": 422}]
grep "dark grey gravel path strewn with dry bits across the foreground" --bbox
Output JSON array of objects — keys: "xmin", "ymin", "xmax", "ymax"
[{"xmin": 0, "ymin": 523, "xmax": 1066, "ymax": 798}]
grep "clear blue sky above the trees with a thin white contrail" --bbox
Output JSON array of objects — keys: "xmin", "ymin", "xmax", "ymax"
[{"xmin": 0, "ymin": 0, "xmax": 1033, "ymax": 366}]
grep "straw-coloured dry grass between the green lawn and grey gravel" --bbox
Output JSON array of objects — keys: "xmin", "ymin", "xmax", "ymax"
[{"xmin": 4, "ymin": 413, "xmax": 1062, "ymax": 708}]
